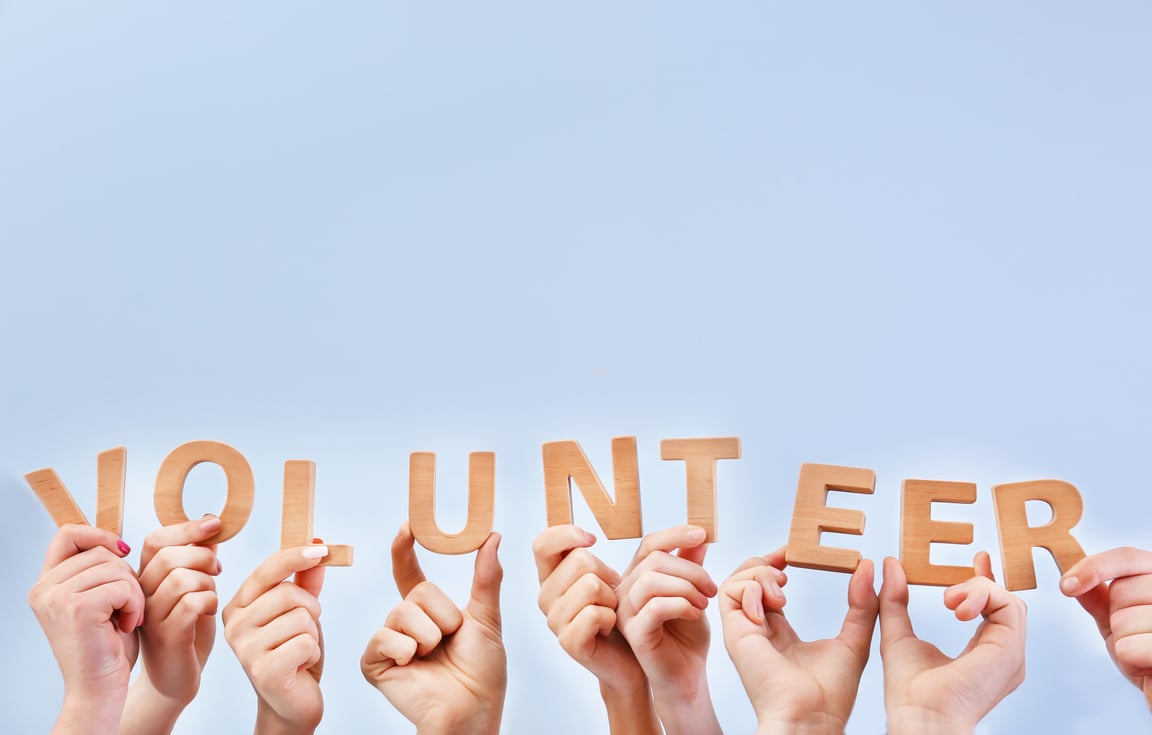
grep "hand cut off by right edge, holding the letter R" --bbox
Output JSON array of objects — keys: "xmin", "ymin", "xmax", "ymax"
[{"xmin": 1060, "ymin": 546, "xmax": 1152, "ymax": 709}]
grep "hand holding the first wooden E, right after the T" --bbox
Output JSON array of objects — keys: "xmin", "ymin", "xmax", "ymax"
[{"xmin": 718, "ymin": 547, "xmax": 879, "ymax": 735}]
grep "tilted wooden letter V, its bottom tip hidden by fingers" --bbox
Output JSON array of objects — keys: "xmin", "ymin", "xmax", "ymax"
[{"xmin": 24, "ymin": 447, "xmax": 128, "ymax": 536}]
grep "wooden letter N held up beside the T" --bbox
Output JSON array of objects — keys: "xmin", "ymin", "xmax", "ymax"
[{"xmin": 544, "ymin": 437, "xmax": 644, "ymax": 538}]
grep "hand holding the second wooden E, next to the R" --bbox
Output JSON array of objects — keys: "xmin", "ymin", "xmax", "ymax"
[{"xmin": 880, "ymin": 552, "xmax": 1028, "ymax": 735}]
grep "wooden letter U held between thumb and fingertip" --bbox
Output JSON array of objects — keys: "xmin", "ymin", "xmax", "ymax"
[{"xmin": 408, "ymin": 452, "xmax": 497, "ymax": 554}]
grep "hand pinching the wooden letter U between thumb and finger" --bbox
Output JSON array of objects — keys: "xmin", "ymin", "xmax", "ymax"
[{"xmin": 361, "ymin": 523, "xmax": 508, "ymax": 735}]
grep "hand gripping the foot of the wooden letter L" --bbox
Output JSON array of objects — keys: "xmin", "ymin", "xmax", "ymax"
[{"xmin": 223, "ymin": 546, "xmax": 328, "ymax": 735}]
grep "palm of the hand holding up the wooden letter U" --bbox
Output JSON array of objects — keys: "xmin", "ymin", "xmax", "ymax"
[{"xmin": 366, "ymin": 611, "xmax": 507, "ymax": 732}]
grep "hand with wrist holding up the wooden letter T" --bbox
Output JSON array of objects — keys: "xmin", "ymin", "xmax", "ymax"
[{"xmin": 616, "ymin": 525, "xmax": 721, "ymax": 735}]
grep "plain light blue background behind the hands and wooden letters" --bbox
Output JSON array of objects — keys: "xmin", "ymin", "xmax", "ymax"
[{"xmin": 0, "ymin": 0, "xmax": 1152, "ymax": 735}]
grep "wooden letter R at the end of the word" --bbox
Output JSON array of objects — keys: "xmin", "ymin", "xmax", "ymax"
[{"xmin": 992, "ymin": 479, "xmax": 1085, "ymax": 592}]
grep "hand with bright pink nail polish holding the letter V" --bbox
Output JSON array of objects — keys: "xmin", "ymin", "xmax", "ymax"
[{"xmin": 28, "ymin": 524, "xmax": 144, "ymax": 735}]
